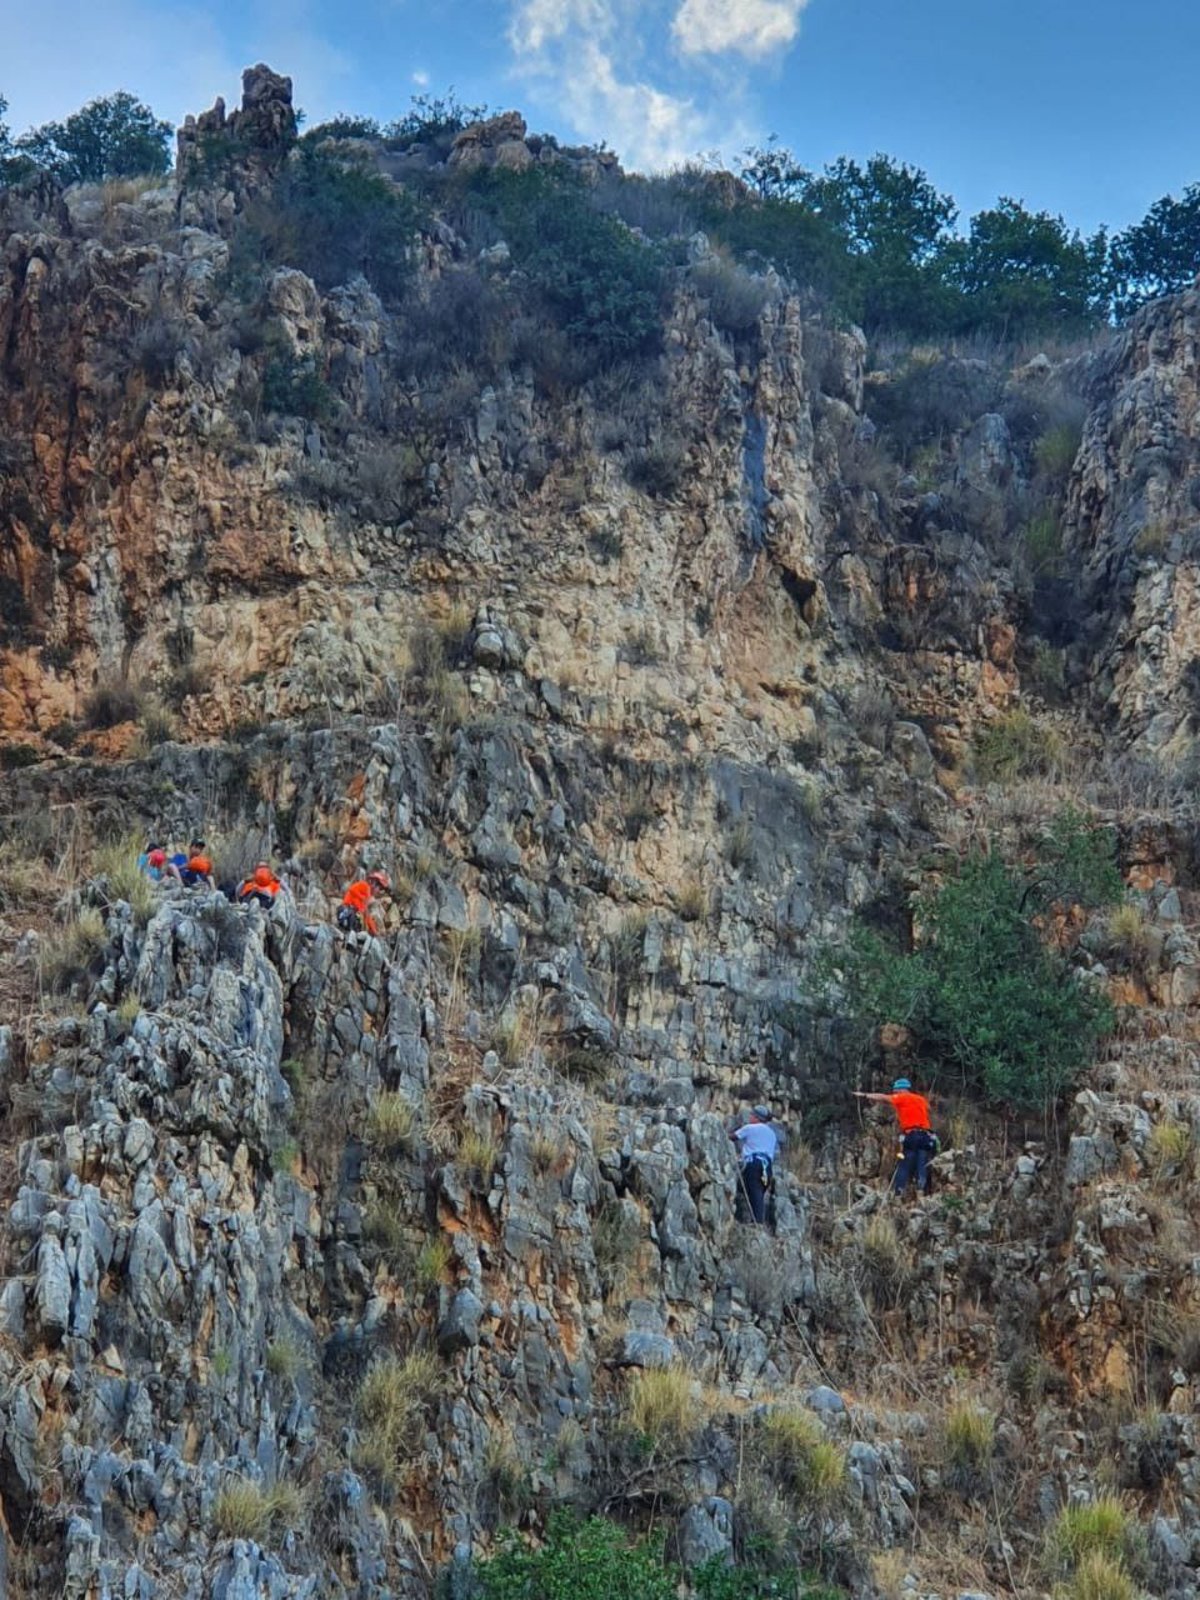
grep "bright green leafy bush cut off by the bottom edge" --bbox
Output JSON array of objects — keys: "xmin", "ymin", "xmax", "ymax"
[{"xmin": 475, "ymin": 1512, "xmax": 678, "ymax": 1600}]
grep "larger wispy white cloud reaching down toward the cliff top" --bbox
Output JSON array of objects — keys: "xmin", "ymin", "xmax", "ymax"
[{"xmin": 509, "ymin": 0, "xmax": 744, "ymax": 171}]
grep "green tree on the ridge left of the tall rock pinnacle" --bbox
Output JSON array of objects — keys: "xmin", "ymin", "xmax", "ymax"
[{"xmin": 16, "ymin": 91, "xmax": 174, "ymax": 184}]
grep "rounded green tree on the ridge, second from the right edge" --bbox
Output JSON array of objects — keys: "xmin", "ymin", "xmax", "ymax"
[{"xmin": 941, "ymin": 198, "xmax": 1109, "ymax": 338}]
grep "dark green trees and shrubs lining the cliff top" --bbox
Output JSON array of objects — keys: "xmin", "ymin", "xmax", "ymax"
[{"xmin": 0, "ymin": 82, "xmax": 1200, "ymax": 339}]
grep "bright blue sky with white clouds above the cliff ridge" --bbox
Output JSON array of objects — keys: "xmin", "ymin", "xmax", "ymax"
[{"xmin": 0, "ymin": 0, "xmax": 1200, "ymax": 229}]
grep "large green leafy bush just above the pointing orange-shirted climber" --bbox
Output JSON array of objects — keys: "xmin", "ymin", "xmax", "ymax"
[{"xmin": 838, "ymin": 854, "xmax": 1112, "ymax": 1106}]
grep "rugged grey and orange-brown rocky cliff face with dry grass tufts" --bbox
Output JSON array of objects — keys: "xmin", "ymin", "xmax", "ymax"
[{"xmin": 0, "ymin": 56, "xmax": 1200, "ymax": 1600}]
